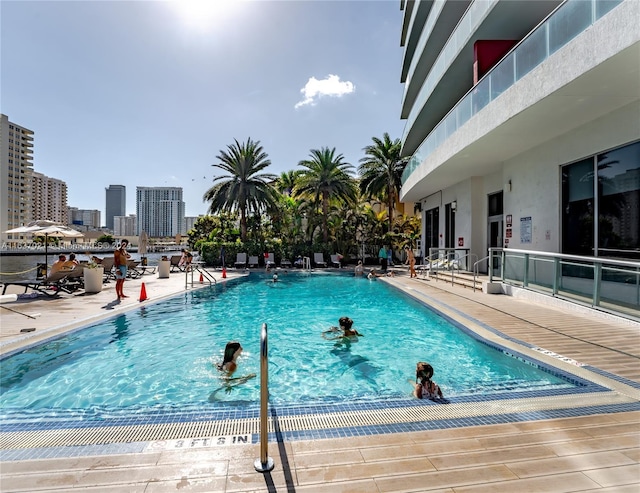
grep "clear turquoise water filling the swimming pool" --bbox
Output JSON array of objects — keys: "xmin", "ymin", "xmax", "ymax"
[{"xmin": 0, "ymin": 273, "xmax": 573, "ymax": 416}]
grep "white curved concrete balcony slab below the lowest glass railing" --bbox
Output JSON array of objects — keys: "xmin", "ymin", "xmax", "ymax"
[{"xmin": 400, "ymin": 41, "xmax": 640, "ymax": 202}]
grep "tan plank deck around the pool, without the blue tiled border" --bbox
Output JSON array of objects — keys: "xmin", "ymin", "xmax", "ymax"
[{"xmin": 0, "ymin": 270, "xmax": 640, "ymax": 493}]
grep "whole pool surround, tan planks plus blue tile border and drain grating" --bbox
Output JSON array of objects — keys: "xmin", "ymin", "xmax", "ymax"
[{"xmin": 0, "ymin": 272, "xmax": 640, "ymax": 493}]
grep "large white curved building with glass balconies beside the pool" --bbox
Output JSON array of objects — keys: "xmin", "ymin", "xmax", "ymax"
[{"xmin": 401, "ymin": 0, "xmax": 640, "ymax": 268}]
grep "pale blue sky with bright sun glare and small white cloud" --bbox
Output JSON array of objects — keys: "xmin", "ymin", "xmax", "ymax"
[{"xmin": 0, "ymin": 0, "xmax": 404, "ymax": 217}]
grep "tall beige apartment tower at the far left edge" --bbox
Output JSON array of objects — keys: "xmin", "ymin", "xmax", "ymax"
[{"xmin": 0, "ymin": 115, "xmax": 33, "ymax": 240}]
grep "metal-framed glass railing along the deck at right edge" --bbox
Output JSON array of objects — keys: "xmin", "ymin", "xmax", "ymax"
[{"xmin": 489, "ymin": 248, "xmax": 640, "ymax": 321}]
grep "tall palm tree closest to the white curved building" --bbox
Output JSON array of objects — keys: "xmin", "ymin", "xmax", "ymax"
[{"xmin": 358, "ymin": 132, "xmax": 408, "ymax": 231}]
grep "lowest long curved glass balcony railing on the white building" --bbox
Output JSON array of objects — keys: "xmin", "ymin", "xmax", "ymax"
[{"xmin": 402, "ymin": 0, "xmax": 630, "ymax": 184}]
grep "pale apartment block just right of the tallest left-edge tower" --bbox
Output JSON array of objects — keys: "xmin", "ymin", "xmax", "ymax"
[{"xmin": 31, "ymin": 171, "xmax": 69, "ymax": 224}]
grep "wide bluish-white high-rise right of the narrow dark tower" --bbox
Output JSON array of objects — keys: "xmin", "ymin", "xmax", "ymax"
[{"xmin": 136, "ymin": 187, "xmax": 186, "ymax": 238}]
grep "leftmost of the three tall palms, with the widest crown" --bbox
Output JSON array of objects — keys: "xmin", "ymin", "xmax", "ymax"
[{"xmin": 203, "ymin": 137, "xmax": 276, "ymax": 241}]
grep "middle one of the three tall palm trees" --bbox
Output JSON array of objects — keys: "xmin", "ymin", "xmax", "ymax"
[{"xmin": 295, "ymin": 147, "xmax": 356, "ymax": 243}]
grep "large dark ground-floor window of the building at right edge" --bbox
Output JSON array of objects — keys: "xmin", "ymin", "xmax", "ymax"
[{"xmin": 562, "ymin": 142, "xmax": 640, "ymax": 259}]
